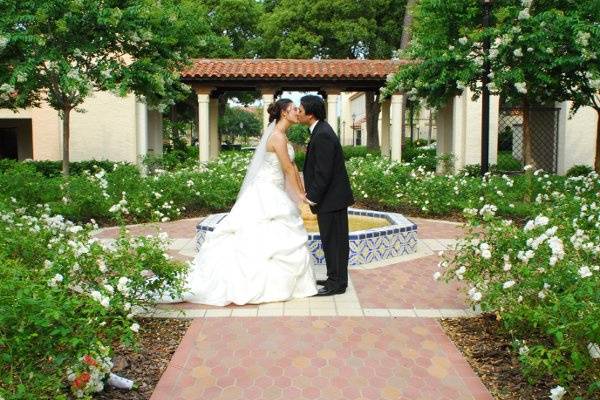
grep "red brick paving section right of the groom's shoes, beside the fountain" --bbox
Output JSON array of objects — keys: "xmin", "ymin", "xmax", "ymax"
[{"xmin": 350, "ymin": 255, "xmax": 467, "ymax": 309}]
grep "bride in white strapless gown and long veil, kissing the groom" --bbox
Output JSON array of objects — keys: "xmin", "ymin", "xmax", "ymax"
[{"xmin": 163, "ymin": 99, "xmax": 317, "ymax": 306}]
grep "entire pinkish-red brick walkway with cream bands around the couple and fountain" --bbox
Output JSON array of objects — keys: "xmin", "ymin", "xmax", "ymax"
[{"xmin": 96, "ymin": 218, "xmax": 492, "ymax": 400}]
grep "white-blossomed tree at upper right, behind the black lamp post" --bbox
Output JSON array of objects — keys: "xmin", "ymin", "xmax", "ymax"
[{"xmin": 385, "ymin": 0, "xmax": 600, "ymax": 170}]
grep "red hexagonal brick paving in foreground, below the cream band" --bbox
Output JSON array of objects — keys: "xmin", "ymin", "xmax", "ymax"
[{"xmin": 151, "ymin": 317, "xmax": 492, "ymax": 400}]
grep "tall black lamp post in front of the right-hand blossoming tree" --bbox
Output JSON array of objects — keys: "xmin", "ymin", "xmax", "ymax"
[{"xmin": 481, "ymin": 0, "xmax": 493, "ymax": 176}]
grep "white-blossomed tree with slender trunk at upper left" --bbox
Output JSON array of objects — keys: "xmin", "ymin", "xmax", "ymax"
[{"xmin": 0, "ymin": 0, "xmax": 221, "ymax": 175}]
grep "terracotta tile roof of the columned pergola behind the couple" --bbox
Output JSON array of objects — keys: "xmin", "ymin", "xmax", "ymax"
[{"xmin": 182, "ymin": 59, "xmax": 408, "ymax": 80}]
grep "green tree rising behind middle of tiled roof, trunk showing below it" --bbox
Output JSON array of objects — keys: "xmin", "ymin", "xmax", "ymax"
[{"xmin": 261, "ymin": 0, "xmax": 406, "ymax": 148}]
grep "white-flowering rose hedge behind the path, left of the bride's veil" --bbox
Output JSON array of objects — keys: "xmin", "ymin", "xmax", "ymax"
[{"xmin": 0, "ymin": 153, "xmax": 250, "ymax": 225}]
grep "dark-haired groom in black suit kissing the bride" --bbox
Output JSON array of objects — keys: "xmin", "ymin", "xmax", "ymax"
[{"xmin": 298, "ymin": 95, "xmax": 354, "ymax": 296}]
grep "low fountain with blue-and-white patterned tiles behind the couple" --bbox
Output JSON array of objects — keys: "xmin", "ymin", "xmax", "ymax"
[{"xmin": 196, "ymin": 208, "xmax": 417, "ymax": 267}]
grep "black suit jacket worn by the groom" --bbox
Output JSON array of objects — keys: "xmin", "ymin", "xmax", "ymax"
[{"xmin": 303, "ymin": 121, "xmax": 354, "ymax": 214}]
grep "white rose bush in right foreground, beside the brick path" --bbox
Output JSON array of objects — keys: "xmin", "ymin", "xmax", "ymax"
[{"xmin": 441, "ymin": 171, "xmax": 600, "ymax": 399}]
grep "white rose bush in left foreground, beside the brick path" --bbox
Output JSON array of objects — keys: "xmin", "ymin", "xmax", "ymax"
[{"xmin": 0, "ymin": 203, "xmax": 185, "ymax": 400}]
